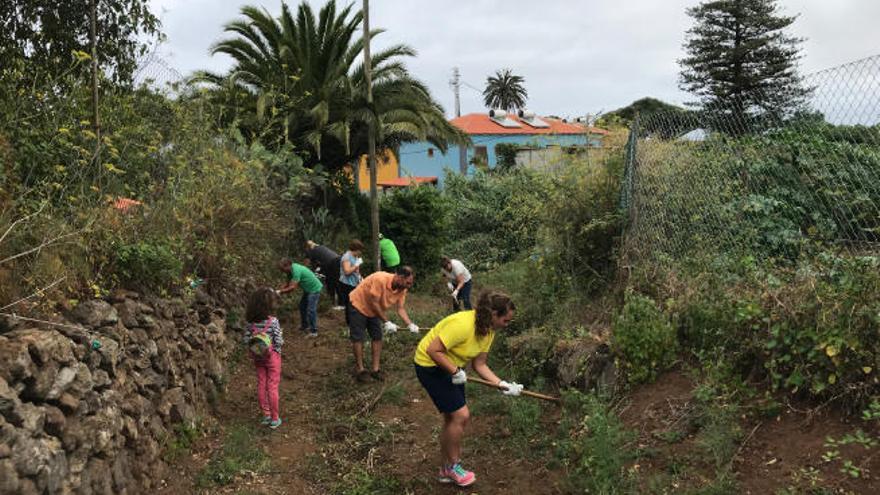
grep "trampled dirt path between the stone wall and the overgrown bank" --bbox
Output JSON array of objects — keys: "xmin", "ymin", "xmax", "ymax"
[{"xmin": 160, "ymin": 300, "xmax": 561, "ymax": 495}]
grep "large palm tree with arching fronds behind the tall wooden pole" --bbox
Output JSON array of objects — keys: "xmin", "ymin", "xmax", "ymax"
[{"xmin": 196, "ymin": 0, "xmax": 466, "ymax": 169}]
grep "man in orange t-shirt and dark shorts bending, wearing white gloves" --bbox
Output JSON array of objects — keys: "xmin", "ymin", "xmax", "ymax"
[{"xmin": 348, "ymin": 266, "xmax": 419, "ymax": 382}]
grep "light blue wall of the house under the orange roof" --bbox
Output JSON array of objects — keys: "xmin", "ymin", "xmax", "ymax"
[{"xmin": 399, "ymin": 134, "xmax": 600, "ymax": 187}]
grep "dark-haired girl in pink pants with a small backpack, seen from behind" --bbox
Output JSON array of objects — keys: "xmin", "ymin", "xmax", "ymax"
[{"xmin": 244, "ymin": 287, "xmax": 284, "ymax": 430}]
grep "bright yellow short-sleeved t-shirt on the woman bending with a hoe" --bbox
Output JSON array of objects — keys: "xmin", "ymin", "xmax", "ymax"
[{"xmin": 413, "ymin": 310, "xmax": 495, "ymax": 367}]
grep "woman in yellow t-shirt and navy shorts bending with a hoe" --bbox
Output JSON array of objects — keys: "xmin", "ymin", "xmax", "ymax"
[{"xmin": 413, "ymin": 291, "xmax": 522, "ymax": 486}]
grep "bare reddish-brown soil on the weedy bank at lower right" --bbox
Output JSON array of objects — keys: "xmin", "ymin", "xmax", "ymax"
[{"xmin": 621, "ymin": 371, "xmax": 880, "ymax": 494}]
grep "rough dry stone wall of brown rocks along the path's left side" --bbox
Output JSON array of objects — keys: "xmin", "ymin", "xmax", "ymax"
[{"xmin": 0, "ymin": 290, "xmax": 235, "ymax": 495}]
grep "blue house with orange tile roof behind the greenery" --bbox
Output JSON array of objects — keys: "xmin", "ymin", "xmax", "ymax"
[{"xmin": 398, "ymin": 110, "xmax": 607, "ymax": 185}]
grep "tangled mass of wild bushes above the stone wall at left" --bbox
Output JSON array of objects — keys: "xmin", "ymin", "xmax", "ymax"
[{"xmin": 0, "ymin": 62, "xmax": 319, "ymax": 300}]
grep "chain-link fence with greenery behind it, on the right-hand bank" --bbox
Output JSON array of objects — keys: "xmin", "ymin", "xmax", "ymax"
[{"xmin": 621, "ymin": 56, "xmax": 880, "ymax": 266}]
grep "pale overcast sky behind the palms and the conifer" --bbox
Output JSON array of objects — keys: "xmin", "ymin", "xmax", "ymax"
[{"xmin": 152, "ymin": 0, "xmax": 880, "ymax": 116}]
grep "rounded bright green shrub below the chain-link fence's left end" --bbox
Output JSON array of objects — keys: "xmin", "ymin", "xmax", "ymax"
[{"xmin": 612, "ymin": 291, "xmax": 678, "ymax": 383}]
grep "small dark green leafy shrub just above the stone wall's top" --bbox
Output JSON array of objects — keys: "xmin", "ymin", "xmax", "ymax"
[{"xmin": 114, "ymin": 241, "xmax": 183, "ymax": 289}]
